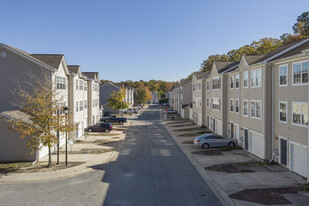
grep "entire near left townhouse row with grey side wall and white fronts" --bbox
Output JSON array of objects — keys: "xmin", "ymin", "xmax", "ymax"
[{"xmin": 0, "ymin": 43, "xmax": 99, "ymax": 161}]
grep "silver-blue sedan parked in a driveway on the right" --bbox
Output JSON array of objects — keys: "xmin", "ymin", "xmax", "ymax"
[{"xmin": 193, "ymin": 133, "xmax": 238, "ymax": 149}]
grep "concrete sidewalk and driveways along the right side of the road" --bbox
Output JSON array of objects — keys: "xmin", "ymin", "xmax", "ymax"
[{"xmin": 163, "ymin": 121, "xmax": 309, "ymax": 206}]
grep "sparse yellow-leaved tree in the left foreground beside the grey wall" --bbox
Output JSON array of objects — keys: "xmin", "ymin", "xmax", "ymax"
[{"xmin": 9, "ymin": 73, "xmax": 75, "ymax": 167}]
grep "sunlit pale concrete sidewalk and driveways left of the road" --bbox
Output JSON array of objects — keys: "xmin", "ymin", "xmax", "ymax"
[{"xmin": 0, "ymin": 124, "xmax": 130, "ymax": 184}]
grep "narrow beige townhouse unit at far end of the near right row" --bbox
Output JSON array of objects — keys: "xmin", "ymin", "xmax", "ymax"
[{"xmin": 189, "ymin": 72, "xmax": 207, "ymax": 126}]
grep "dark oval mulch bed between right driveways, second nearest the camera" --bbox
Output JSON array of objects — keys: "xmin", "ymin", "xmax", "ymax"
[{"xmin": 205, "ymin": 164, "xmax": 255, "ymax": 173}]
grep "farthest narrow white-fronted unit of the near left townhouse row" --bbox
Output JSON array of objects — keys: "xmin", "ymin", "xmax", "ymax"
[{"xmin": 80, "ymin": 72, "xmax": 102, "ymax": 125}]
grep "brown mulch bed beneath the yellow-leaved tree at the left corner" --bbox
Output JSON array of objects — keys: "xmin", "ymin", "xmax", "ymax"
[{"xmin": 0, "ymin": 162, "xmax": 85, "ymax": 174}]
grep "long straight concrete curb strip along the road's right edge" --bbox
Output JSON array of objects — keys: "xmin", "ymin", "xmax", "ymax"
[{"xmin": 162, "ymin": 122, "xmax": 236, "ymax": 206}]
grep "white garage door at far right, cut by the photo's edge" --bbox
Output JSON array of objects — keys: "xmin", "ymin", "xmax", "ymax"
[{"xmin": 290, "ymin": 143, "xmax": 307, "ymax": 177}]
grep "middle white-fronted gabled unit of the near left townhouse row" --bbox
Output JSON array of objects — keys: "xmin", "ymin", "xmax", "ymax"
[{"xmin": 68, "ymin": 65, "xmax": 89, "ymax": 138}]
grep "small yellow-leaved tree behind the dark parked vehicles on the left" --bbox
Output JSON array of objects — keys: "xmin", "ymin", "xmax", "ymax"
[{"xmin": 107, "ymin": 87, "xmax": 129, "ymax": 110}]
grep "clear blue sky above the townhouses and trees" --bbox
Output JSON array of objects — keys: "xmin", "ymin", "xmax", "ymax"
[{"xmin": 0, "ymin": 0, "xmax": 309, "ymax": 81}]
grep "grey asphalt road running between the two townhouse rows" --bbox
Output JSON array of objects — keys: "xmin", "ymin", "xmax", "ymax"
[{"xmin": 0, "ymin": 105, "xmax": 221, "ymax": 206}]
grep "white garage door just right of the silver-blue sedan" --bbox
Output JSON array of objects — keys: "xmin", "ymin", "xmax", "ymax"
[{"xmin": 249, "ymin": 132, "xmax": 264, "ymax": 159}]
